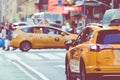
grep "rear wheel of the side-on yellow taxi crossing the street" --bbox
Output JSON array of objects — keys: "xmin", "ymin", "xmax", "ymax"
[{"xmin": 20, "ymin": 41, "xmax": 31, "ymax": 52}]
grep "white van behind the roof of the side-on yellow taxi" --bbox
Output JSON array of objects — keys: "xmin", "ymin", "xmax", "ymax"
[{"xmin": 32, "ymin": 12, "xmax": 63, "ymax": 25}]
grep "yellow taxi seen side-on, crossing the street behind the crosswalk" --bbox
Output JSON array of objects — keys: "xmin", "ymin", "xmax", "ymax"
[{"xmin": 10, "ymin": 25, "xmax": 77, "ymax": 52}]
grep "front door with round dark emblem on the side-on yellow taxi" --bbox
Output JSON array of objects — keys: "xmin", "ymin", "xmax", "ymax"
[{"xmin": 43, "ymin": 28, "xmax": 66, "ymax": 48}]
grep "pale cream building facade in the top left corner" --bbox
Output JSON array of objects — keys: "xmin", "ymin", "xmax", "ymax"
[{"xmin": 0, "ymin": 0, "xmax": 17, "ymax": 22}]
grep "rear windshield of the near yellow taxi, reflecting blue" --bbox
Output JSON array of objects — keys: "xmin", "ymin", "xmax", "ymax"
[{"xmin": 97, "ymin": 30, "xmax": 120, "ymax": 44}]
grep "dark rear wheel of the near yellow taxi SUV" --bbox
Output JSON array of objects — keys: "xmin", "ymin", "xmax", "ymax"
[{"xmin": 80, "ymin": 60, "xmax": 87, "ymax": 80}]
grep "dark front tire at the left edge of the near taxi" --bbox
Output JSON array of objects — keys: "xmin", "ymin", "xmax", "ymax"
[{"xmin": 65, "ymin": 57, "xmax": 77, "ymax": 80}]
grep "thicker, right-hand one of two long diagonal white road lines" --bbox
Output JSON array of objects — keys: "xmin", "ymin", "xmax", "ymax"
[{"xmin": 17, "ymin": 60, "xmax": 49, "ymax": 80}]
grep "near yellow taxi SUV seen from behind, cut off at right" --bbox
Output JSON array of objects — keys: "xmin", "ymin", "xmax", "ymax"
[{"xmin": 65, "ymin": 23, "xmax": 120, "ymax": 80}]
